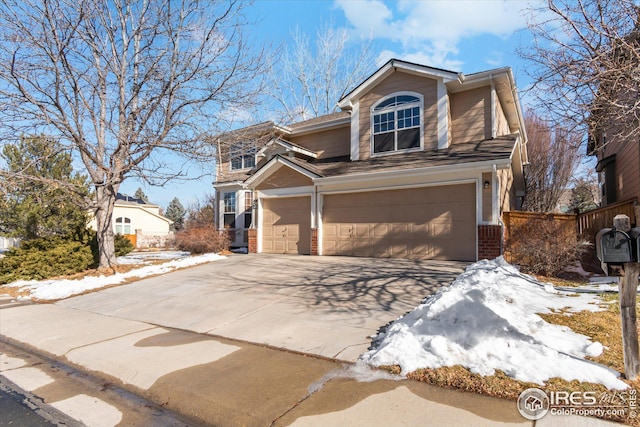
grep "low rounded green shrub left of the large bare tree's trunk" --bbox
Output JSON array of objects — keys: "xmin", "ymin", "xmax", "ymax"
[{"xmin": 0, "ymin": 237, "xmax": 95, "ymax": 284}]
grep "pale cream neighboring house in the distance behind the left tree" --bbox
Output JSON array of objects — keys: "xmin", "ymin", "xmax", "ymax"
[{"xmin": 89, "ymin": 193, "xmax": 173, "ymax": 248}]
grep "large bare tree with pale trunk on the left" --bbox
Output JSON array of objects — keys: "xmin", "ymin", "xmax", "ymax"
[{"xmin": 0, "ymin": 0, "xmax": 263, "ymax": 268}]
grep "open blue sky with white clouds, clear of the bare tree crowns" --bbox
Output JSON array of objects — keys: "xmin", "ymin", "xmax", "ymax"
[{"xmin": 121, "ymin": 0, "xmax": 544, "ymax": 207}]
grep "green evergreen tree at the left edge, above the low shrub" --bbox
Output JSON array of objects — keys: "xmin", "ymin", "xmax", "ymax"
[{"xmin": 0, "ymin": 136, "xmax": 89, "ymax": 240}]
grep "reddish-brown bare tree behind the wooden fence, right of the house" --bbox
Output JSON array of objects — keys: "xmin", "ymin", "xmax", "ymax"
[{"xmin": 523, "ymin": 112, "xmax": 580, "ymax": 212}]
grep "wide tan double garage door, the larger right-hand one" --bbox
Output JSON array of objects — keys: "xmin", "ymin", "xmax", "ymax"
[{"xmin": 322, "ymin": 184, "xmax": 476, "ymax": 261}]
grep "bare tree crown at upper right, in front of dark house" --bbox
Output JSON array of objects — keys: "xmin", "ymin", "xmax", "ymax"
[{"xmin": 520, "ymin": 0, "xmax": 640, "ymax": 149}]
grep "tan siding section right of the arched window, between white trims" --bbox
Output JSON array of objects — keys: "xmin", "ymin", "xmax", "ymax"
[{"xmin": 449, "ymin": 86, "xmax": 491, "ymax": 144}]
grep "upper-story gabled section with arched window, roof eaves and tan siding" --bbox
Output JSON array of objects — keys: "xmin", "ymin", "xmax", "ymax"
[{"xmin": 338, "ymin": 59, "xmax": 526, "ymax": 161}]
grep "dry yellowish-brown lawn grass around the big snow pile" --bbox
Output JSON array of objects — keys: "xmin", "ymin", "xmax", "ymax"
[{"xmin": 402, "ymin": 278, "xmax": 640, "ymax": 426}]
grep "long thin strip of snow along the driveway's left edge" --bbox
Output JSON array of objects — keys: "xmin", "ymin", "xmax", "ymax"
[{"xmin": 4, "ymin": 254, "xmax": 225, "ymax": 300}]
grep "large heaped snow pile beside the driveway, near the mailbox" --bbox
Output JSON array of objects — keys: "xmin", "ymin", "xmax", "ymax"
[{"xmin": 361, "ymin": 258, "xmax": 627, "ymax": 389}]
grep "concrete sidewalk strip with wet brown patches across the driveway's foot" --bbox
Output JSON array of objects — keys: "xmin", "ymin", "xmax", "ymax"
[{"xmin": 0, "ymin": 304, "xmax": 536, "ymax": 426}]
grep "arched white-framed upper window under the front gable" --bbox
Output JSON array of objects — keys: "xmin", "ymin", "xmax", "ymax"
[{"xmin": 371, "ymin": 94, "xmax": 423, "ymax": 154}]
